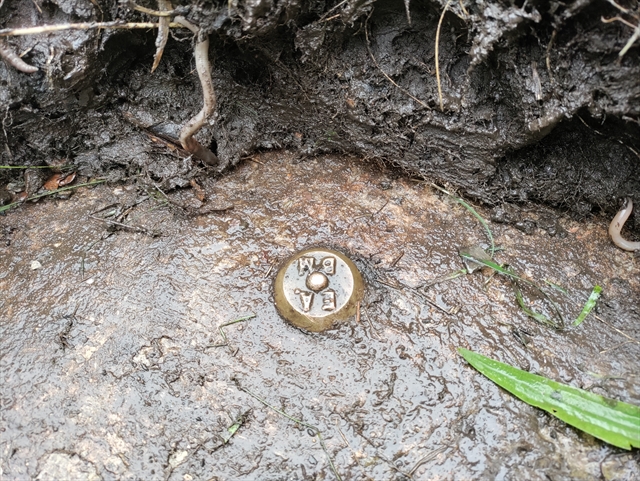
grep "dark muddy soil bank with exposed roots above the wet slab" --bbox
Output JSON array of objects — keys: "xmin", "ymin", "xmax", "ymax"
[{"xmin": 0, "ymin": 0, "xmax": 640, "ymax": 234}]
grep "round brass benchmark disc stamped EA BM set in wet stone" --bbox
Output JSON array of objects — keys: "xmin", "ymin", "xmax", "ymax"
[{"xmin": 274, "ymin": 247, "xmax": 364, "ymax": 332}]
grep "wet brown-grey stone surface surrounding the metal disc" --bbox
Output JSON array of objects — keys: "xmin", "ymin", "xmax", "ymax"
[{"xmin": 0, "ymin": 152, "xmax": 640, "ymax": 480}]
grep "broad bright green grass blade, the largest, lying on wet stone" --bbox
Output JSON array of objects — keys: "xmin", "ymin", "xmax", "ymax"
[{"xmin": 458, "ymin": 348, "xmax": 640, "ymax": 449}]
